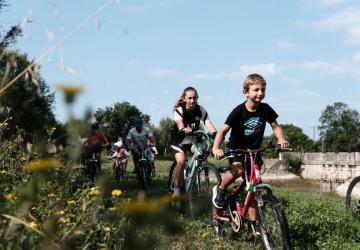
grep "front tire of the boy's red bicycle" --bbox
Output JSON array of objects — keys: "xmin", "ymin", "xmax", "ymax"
[{"xmin": 257, "ymin": 194, "xmax": 291, "ymax": 250}]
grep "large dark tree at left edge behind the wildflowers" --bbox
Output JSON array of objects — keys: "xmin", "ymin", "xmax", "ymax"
[{"xmin": 0, "ymin": 52, "xmax": 65, "ymax": 144}]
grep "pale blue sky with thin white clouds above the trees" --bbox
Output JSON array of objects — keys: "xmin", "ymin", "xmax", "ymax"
[{"xmin": 0, "ymin": 0, "xmax": 360, "ymax": 138}]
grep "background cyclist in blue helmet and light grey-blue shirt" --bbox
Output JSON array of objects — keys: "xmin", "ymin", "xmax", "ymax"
[{"xmin": 126, "ymin": 119, "xmax": 157, "ymax": 173}]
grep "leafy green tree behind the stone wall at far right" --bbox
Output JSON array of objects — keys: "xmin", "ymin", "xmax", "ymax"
[{"xmin": 318, "ymin": 102, "xmax": 360, "ymax": 152}]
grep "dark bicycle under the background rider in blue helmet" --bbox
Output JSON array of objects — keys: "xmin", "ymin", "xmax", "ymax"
[{"xmin": 137, "ymin": 146, "xmax": 155, "ymax": 190}]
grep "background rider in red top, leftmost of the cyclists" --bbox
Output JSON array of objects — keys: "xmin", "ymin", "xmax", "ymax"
[{"xmin": 84, "ymin": 122, "xmax": 109, "ymax": 172}]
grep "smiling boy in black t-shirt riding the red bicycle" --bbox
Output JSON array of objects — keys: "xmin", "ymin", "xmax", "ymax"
[{"xmin": 212, "ymin": 74, "xmax": 289, "ymax": 233}]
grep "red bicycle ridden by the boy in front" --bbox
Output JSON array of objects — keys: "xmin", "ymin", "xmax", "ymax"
[{"xmin": 211, "ymin": 143, "xmax": 291, "ymax": 249}]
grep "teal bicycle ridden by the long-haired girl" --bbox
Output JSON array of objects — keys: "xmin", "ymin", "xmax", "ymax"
[{"xmin": 168, "ymin": 131, "xmax": 221, "ymax": 216}]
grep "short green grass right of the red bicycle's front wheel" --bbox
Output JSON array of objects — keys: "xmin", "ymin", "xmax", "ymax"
[{"xmin": 276, "ymin": 190, "xmax": 360, "ymax": 249}]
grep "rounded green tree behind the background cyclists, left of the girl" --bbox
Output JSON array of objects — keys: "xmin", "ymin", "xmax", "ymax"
[{"xmin": 94, "ymin": 102, "xmax": 150, "ymax": 141}]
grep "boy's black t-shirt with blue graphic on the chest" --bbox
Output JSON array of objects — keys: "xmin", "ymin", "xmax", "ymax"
[{"xmin": 225, "ymin": 102, "xmax": 278, "ymax": 149}]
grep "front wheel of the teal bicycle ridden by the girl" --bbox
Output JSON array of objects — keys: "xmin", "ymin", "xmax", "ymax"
[{"xmin": 190, "ymin": 163, "xmax": 221, "ymax": 215}]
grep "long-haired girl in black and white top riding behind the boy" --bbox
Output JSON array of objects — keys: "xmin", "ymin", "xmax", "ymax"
[{"xmin": 170, "ymin": 87, "xmax": 216, "ymax": 196}]
